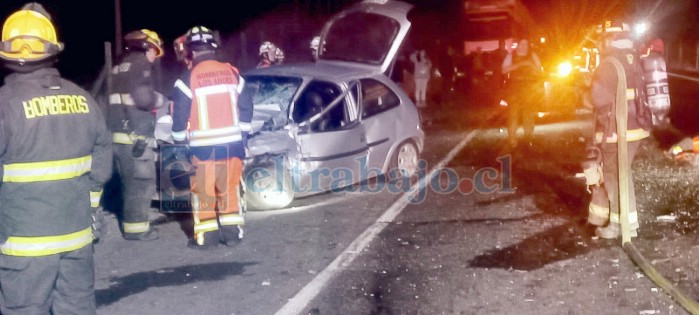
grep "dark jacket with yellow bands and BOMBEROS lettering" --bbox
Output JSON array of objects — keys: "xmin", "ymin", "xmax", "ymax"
[{"xmin": 0, "ymin": 68, "xmax": 112, "ymax": 256}]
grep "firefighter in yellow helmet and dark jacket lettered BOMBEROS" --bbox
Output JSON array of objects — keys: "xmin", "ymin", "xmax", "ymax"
[{"xmin": 0, "ymin": 3, "xmax": 112, "ymax": 314}]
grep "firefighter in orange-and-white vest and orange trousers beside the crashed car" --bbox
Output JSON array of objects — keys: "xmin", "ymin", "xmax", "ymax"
[{"xmin": 172, "ymin": 26, "xmax": 252, "ymax": 249}]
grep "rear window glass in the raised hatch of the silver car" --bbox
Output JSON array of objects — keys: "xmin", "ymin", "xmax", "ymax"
[{"xmin": 321, "ymin": 13, "xmax": 400, "ymax": 65}]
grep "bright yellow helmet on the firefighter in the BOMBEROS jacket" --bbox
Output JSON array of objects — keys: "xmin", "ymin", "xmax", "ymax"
[{"xmin": 0, "ymin": 6, "xmax": 63, "ymax": 64}]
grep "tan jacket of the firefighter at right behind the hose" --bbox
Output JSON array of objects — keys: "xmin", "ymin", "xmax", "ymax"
[{"xmin": 590, "ymin": 50, "xmax": 650, "ymax": 143}]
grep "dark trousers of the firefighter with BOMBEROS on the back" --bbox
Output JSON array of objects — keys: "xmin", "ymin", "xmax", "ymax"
[{"xmin": 0, "ymin": 244, "xmax": 97, "ymax": 315}]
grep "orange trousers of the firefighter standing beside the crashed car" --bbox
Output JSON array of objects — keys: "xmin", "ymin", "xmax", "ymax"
[{"xmin": 190, "ymin": 157, "xmax": 245, "ymax": 245}]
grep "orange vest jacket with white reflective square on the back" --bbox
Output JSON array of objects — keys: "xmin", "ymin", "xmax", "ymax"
[{"xmin": 172, "ymin": 54, "xmax": 252, "ymax": 160}]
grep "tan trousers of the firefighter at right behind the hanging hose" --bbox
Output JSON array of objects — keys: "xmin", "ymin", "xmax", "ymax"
[{"xmin": 588, "ymin": 141, "xmax": 641, "ymax": 230}]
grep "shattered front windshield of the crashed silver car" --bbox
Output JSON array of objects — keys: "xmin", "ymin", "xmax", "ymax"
[{"xmin": 245, "ymin": 76, "xmax": 303, "ymax": 126}]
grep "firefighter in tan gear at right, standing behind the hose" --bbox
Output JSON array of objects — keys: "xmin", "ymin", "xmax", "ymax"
[{"xmin": 588, "ymin": 22, "xmax": 651, "ymax": 239}]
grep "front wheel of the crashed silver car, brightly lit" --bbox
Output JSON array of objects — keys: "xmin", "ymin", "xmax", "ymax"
[{"xmin": 243, "ymin": 160, "xmax": 294, "ymax": 211}]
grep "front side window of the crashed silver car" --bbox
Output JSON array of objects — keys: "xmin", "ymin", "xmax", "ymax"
[{"xmin": 292, "ymin": 81, "xmax": 349, "ymax": 132}]
